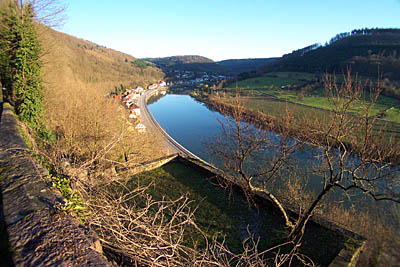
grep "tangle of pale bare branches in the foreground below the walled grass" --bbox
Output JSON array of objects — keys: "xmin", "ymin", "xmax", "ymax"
[{"xmin": 79, "ymin": 170, "xmax": 314, "ymax": 267}]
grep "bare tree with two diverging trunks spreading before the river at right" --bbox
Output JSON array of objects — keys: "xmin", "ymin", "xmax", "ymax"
[{"xmin": 212, "ymin": 73, "xmax": 400, "ymax": 242}]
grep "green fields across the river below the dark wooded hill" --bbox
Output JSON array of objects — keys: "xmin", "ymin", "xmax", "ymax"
[{"xmin": 223, "ymin": 72, "xmax": 400, "ymax": 123}]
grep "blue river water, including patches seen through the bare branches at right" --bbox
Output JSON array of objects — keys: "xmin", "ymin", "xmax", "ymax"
[{"xmin": 149, "ymin": 94, "xmax": 400, "ymax": 228}]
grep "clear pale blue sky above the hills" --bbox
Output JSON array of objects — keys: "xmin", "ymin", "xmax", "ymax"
[{"xmin": 58, "ymin": 0, "xmax": 400, "ymax": 61}]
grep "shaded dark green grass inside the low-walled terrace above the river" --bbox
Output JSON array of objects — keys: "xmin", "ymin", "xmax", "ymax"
[{"xmin": 108, "ymin": 161, "xmax": 344, "ymax": 266}]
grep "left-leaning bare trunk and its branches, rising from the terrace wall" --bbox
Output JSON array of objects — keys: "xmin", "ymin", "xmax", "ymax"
[{"xmin": 210, "ymin": 95, "xmax": 300, "ymax": 233}]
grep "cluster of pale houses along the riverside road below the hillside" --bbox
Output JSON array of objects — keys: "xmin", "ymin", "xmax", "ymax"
[{"xmin": 113, "ymin": 81, "xmax": 167, "ymax": 132}]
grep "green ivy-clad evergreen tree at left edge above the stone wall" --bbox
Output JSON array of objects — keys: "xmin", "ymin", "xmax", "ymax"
[{"xmin": 1, "ymin": 3, "xmax": 43, "ymax": 130}]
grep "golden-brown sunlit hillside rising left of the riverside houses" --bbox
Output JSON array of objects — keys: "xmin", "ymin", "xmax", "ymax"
[{"xmin": 39, "ymin": 26, "xmax": 164, "ymax": 165}]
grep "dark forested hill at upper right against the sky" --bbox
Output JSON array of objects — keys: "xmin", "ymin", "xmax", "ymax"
[{"xmin": 258, "ymin": 29, "xmax": 400, "ymax": 80}]
